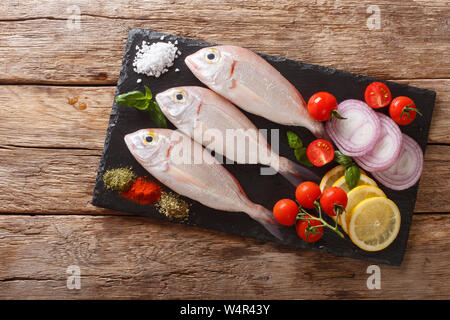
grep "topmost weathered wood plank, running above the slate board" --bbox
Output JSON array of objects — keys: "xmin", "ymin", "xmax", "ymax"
[{"xmin": 0, "ymin": 0, "xmax": 450, "ymax": 84}]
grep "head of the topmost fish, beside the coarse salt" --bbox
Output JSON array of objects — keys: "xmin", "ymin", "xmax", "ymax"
[{"xmin": 184, "ymin": 46, "xmax": 234, "ymax": 86}]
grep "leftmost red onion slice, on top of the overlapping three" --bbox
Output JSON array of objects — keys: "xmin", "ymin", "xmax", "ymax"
[{"xmin": 326, "ymin": 99, "xmax": 381, "ymax": 157}]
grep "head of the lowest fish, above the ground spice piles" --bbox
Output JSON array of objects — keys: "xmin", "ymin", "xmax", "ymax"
[{"xmin": 124, "ymin": 129, "xmax": 172, "ymax": 168}]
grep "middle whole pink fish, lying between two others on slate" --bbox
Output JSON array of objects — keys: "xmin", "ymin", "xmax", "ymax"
[{"xmin": 156, "ymin": 86, "xmax": 319, "ymax": 187}]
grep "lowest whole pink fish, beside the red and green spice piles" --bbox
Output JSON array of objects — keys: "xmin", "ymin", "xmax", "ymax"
[{"xmin": 124, "ymin": 129, "xmax": 282, "ymax": 239}]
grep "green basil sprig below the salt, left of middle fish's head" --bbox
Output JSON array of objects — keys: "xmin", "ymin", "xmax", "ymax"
[{"xmin": 115, "ymin": 85, "xmax": 167, "ymax": 128}]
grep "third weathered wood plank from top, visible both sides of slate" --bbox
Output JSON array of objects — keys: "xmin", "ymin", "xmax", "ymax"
[{"xmin": 0, "ymin": 145, "xmax": 450, "ymax": 214}]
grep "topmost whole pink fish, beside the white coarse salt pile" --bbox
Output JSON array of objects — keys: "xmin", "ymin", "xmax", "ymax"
[{"xmin": 185, "ymin": 46, "xmax": 326, "ymax": 137}]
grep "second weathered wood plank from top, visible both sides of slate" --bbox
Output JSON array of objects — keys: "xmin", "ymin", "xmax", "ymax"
[{"xmin": 0, "ymin": 80, "xmax": 444, "ymax": 150}]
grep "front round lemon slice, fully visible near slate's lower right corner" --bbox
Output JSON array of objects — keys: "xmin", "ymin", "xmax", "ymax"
[{"xmin": 348, "ymin": 197, "xmax": 401, "ymax": 251}]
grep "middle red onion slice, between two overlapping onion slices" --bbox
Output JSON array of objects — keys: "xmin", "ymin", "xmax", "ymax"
[{"xmin": 353, "ymin": 113, "xmax": 403, "ymax": 172}]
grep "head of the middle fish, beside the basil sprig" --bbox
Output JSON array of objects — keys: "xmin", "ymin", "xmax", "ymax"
[{"xmin": 155, "ymin": 87, "xmax": 201, "ymax": 127}]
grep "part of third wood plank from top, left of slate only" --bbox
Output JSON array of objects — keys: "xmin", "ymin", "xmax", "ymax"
[{"xmin": 0, "ymin": 147, "xmax": 112, "ymax": 214}]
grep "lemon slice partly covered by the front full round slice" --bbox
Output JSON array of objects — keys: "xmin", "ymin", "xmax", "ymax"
[{"xmin": 339, "ymin": 185, "xmax": 386, "ymax": 232}]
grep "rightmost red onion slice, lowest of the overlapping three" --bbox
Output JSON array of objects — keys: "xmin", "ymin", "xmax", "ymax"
[{"xmin": 372, "ymin": 134, "xmax": 423, "ymax": 190}]
